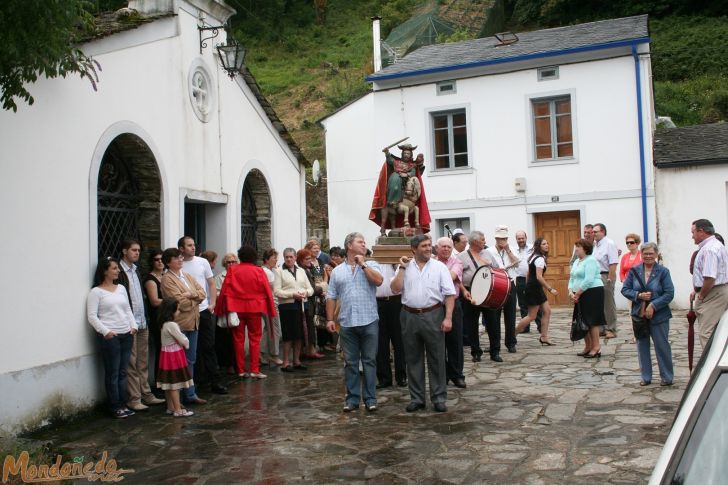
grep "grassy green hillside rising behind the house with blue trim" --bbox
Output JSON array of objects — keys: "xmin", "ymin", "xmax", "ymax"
[{"xmin": 228, "ymin": 0, "xmax": 728, "ymax": 164}]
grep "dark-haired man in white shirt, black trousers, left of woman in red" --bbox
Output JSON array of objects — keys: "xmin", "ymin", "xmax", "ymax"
[{"xmin": 177, "ymin": 236, "xmax": 228, "ymax": 394}]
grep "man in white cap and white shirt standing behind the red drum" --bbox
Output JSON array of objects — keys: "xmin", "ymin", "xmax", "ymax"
[{"xmin": 486, "ymin": 226, "xmax": 521, "ymax": 354}]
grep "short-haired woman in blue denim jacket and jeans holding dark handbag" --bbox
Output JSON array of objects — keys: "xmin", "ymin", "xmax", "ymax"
[{"xmin": 622, "ymin": 242, "xmax": 675, "ymax": 386}]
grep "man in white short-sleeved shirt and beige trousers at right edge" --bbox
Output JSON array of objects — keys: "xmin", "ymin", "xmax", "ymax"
[{"xmin": 690, "ymin": 219, "xmax": 728, "ymax": 348}]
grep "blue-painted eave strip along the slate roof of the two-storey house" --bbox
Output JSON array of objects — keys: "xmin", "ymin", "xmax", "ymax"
[{"xmin": 366, "ymin": 37, "xmax": 650, "ymax": 82}]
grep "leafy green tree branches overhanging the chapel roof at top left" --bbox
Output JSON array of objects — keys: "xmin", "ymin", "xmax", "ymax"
[{"xmin": 0, "ymin": 0, "xmax": 101, "ymax": 111}]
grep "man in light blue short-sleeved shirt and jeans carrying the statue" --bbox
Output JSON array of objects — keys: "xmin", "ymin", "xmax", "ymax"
[{"xmin": 326, "ymin": 232, "xmax": 384, "ymax": 413}]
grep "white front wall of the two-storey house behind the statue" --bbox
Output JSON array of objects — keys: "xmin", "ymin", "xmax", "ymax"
[{"xmin": 323, "ymin": 56, "xmax": 655, "ymax": 308}]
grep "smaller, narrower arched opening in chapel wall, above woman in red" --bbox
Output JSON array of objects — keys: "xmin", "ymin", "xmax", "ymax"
[{"xmin": 240, "ymin": 169, "xmax": 273, "ymax": 256}]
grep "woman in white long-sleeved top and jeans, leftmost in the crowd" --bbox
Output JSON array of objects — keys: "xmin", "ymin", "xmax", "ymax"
[{"xmin": 86, "ymin": 258, "xmax": 137, "ymax": 418}]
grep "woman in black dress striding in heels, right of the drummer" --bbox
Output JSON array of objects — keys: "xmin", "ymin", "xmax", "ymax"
[{"xmin": 516, "ymin": 237, "xmax": 559, "ymax": 346}]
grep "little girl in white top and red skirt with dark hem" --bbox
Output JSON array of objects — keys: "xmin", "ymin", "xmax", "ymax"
[{"xmin": 157, "ymin": 298, "xmax": 195, "ymax": 417}]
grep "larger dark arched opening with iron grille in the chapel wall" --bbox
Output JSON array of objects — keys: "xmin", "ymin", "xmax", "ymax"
[{"xmin": 96, "ymin": 133, "xmax": 162, "ymax": 270}]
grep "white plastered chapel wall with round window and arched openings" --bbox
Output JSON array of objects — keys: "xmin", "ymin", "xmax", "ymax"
[{"xmin": 0, "ymin": 2, "xmax": 305, "ymax": 434}]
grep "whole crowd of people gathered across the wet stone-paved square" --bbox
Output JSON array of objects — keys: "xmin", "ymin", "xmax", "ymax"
[{"xmin": 87, "ymin": 219, "xmax": 728, "ymax": 418}]
